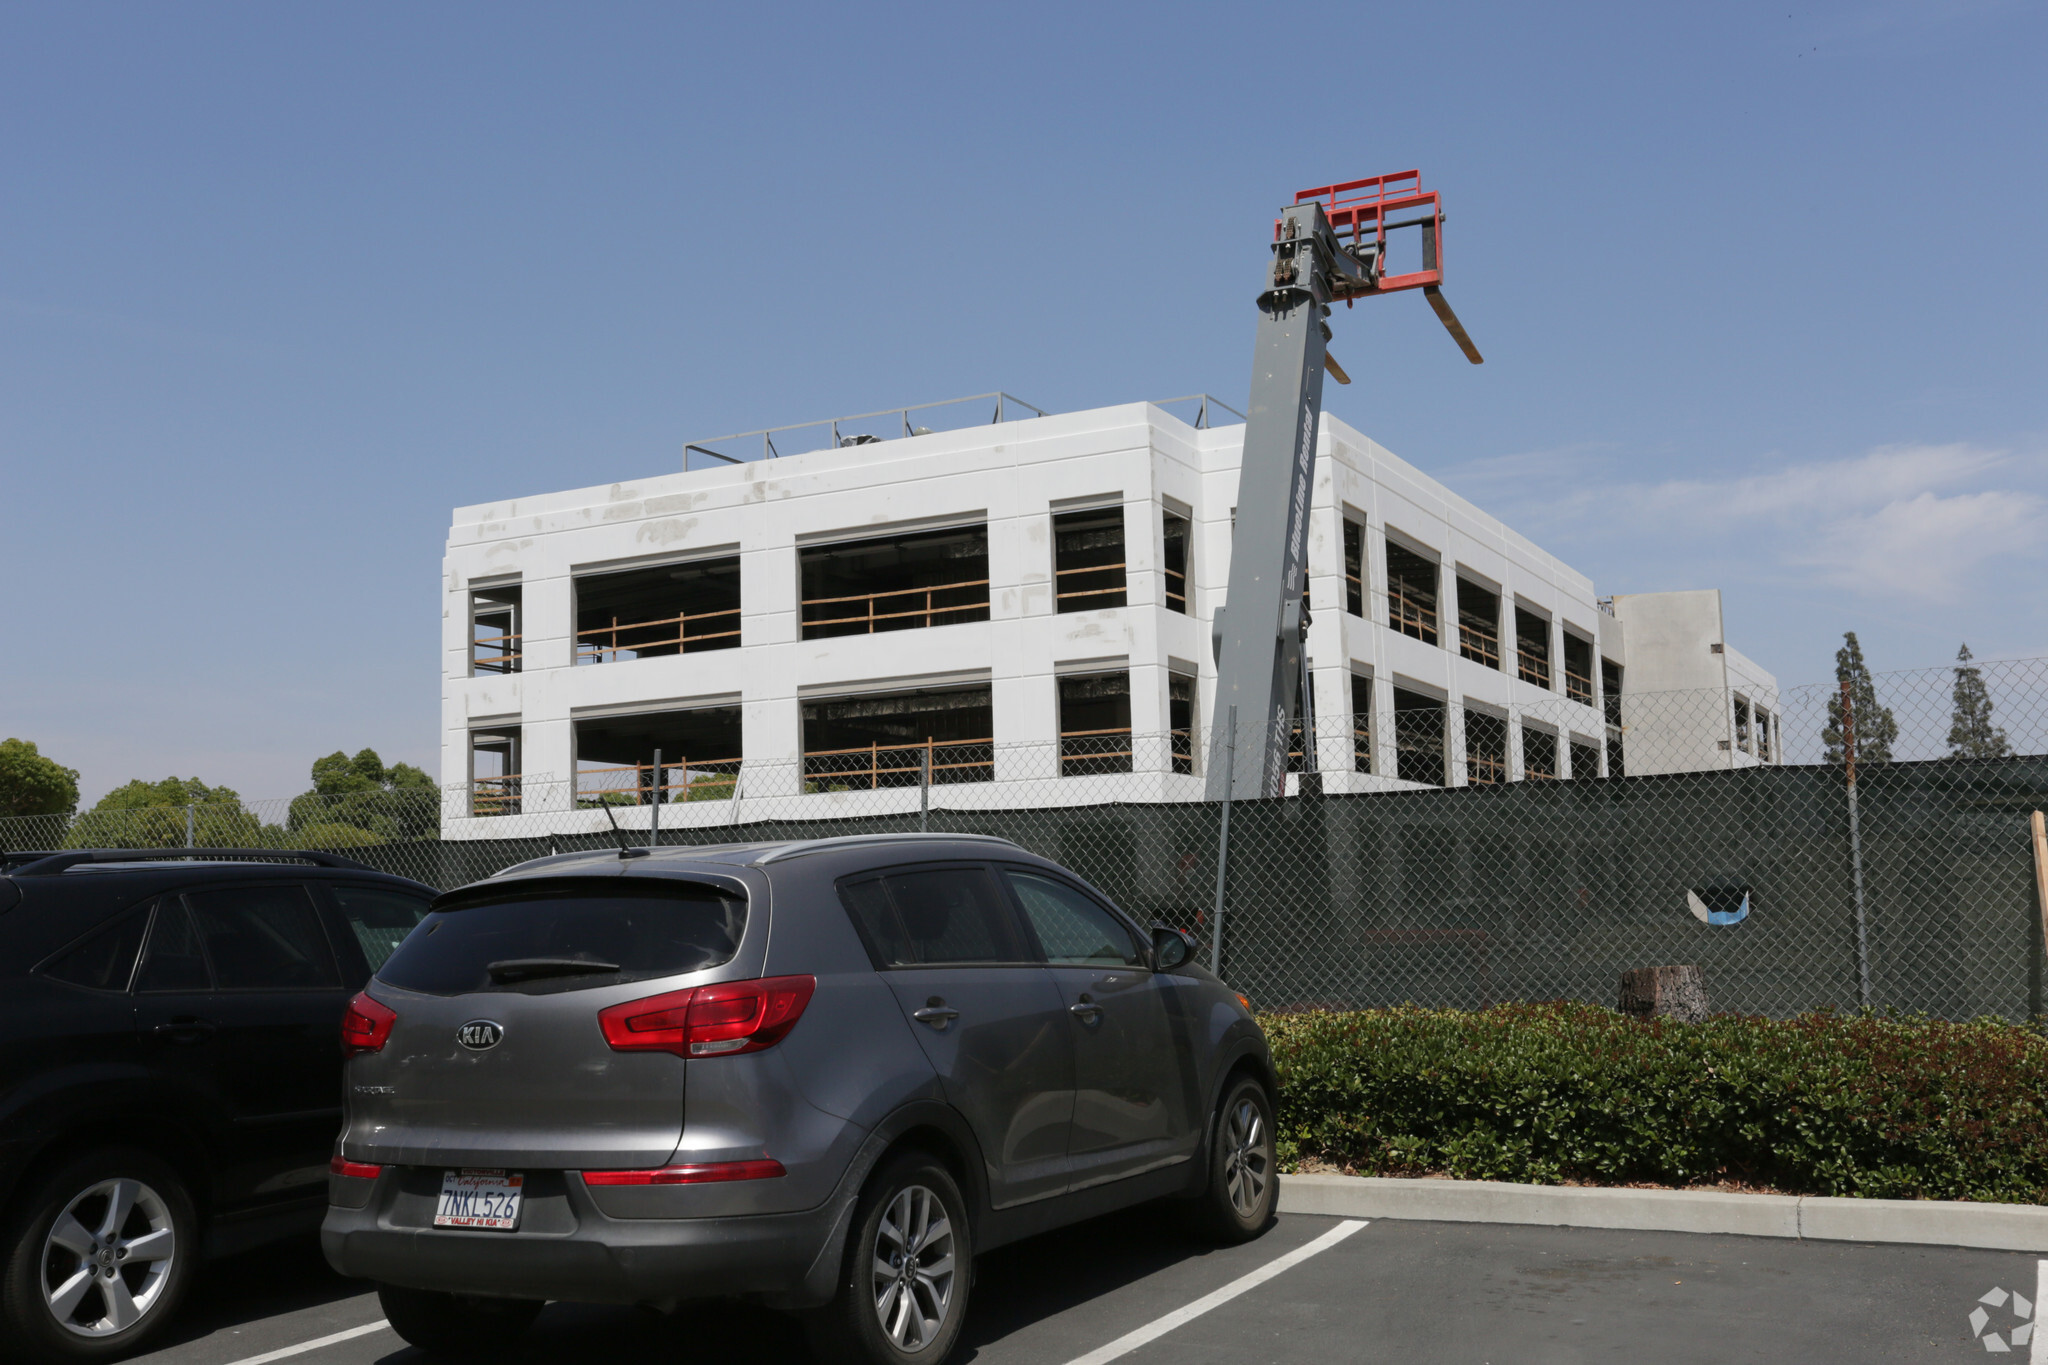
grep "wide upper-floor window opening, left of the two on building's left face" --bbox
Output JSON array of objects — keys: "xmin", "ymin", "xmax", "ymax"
[{"xmin": 575, "ymin": 555, "xmax": 739, "ymax": 663}]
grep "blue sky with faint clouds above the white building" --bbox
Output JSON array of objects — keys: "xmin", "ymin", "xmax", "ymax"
[{"xmin": 0, "ymin": 0, "xmax": 2048, "ymax": 800}]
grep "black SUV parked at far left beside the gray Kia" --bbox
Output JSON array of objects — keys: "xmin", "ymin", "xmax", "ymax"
[{"xmin": 0, "ymin": 849, "xmax": 434, "ymax": 1361}]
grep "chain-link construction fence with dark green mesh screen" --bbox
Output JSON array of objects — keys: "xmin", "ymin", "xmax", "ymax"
[{"xmin": 16, "ymin": 659, "xmax": 2048, "ymax": 1019}]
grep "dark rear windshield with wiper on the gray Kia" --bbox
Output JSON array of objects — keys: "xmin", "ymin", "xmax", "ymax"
[{"xmin": 377, "ymin": 882, "xmax": 748, "ymax": 995}]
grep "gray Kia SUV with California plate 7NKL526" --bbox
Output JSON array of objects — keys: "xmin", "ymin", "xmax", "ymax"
[{"xmin": 322, "ymin": 835, "xmax": 1278, "ymax": 1365}]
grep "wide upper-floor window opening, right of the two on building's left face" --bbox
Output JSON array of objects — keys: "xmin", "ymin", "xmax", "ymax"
[{"xmin": 797, "ymin": 524, "xmax": 989, "ymax": 641}]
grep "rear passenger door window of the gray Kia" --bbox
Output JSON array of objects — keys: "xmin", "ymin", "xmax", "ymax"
[{"xmin": 840, "ymin": 868, "xmax": 1026, "ymax": 966}]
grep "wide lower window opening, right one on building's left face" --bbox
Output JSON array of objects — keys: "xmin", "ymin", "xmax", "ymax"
[{"xmin": 803, "ymin": 686, "xmax": 995, "ymax": 792}]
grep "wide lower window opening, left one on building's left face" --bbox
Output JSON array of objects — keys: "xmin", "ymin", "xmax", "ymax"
[{"xmin": 575, "ymin": 706, "xmax": 739, "ymax": 808}]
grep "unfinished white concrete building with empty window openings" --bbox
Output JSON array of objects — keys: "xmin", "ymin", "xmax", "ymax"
[{"xmin": 442, "ymin": 403, "xmax": 1776, "ymax": 833}]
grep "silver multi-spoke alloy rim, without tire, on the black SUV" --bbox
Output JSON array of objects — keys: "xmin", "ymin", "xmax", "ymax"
[{"xmin": 43, "ymin": 1177, "xmax": 178, "ymax": 1338}]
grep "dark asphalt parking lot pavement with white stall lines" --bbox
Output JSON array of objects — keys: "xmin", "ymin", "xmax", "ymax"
[{"xmin": 123, "ymin": 1209, "xmax": 2048, "ymax": 1365}]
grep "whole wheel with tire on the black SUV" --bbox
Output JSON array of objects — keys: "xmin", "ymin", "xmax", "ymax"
[{"xmin": 0, "ymin": 1148, "xmax": 199, "ymax": 1361}]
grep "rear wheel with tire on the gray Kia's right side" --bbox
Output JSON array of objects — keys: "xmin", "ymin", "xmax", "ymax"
[{"xmin": 805, "ymin": 1152, "xmax": 975, "ymax": 1365}]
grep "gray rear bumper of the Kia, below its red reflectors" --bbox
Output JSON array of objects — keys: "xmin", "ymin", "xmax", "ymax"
[{"xmin": 319, "ymin": 1169, "xmax": 852, "ymax": 1308}]
